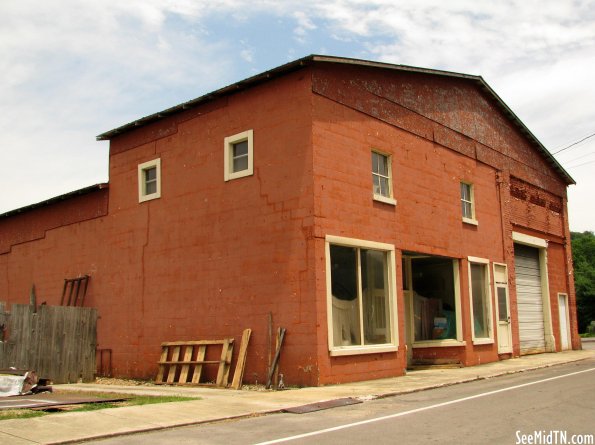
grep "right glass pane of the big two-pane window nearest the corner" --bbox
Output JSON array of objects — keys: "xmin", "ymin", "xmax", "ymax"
[{"xmin": 361, "ymin": 249, "xmax": 390, "ymax": 345}]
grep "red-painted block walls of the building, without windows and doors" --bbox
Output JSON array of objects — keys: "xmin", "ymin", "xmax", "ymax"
[{"xmin": 0, "ymin": 59, "xmax": 576, "ymax": 385}]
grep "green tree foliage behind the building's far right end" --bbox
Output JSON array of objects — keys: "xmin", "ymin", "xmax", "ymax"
[{"xmin": 571, "ymin": 232, "xmax": 595, "ymax": 332}]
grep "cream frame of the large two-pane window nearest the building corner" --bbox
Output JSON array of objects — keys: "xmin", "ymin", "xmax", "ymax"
[{"xmin": 325, "ymin": 235, "xmax": 399, "ymax": 356}]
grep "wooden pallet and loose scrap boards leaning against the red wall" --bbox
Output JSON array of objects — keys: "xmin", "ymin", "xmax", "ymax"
[{"xmin": 155, "ymin": 322, "xmax": 285, "ymax": 389}]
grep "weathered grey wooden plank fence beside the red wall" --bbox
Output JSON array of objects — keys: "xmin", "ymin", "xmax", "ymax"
[{"xmin": 0, "ymin": 303, "xmax": 97, "ymax": 383}]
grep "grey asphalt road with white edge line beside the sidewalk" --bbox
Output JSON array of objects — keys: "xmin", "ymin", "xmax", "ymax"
[{"xmin": 87, "ymin": 359, "xmax": 595, "ymax": 445}]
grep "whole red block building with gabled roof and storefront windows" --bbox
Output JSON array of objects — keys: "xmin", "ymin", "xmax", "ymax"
[{"xmin": 0, "ymin": 56, "xmax": 580, "ymax": 385}]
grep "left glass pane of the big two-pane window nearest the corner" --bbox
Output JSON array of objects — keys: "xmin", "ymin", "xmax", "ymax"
[{"xmin": 330, "ymin": 246, "xmax": 361, "ymax": 346}]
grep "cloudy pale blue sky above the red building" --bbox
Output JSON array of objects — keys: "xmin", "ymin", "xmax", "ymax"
[{"xmin": 0, "ymin": 0, "xmax": 595, "ymax": 231}]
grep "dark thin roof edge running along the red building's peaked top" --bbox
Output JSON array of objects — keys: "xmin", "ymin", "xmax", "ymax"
[{"xmin": 97, "ymin": 54, "xmax": 576, "ymax": 184}]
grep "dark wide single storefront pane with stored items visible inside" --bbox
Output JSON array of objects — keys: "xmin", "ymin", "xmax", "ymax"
[{"xmin": 411, "ymin": 256, "xmax": 457, "ymax": 341}]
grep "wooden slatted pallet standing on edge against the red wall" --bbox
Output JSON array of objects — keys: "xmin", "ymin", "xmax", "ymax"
[{"xmin": 155, "ymin": 338, "xmax": 234, "ymax": 387}]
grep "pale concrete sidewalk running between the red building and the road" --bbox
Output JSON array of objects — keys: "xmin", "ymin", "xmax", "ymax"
[{"xmin": 0, "ymin": 350, "xmax": 595, "ymax": 444}]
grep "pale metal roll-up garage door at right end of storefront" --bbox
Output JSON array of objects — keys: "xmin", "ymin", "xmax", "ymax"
[{"xmin": 514, "ymin": 244, "xmax": 545, "ymax": 354}]
